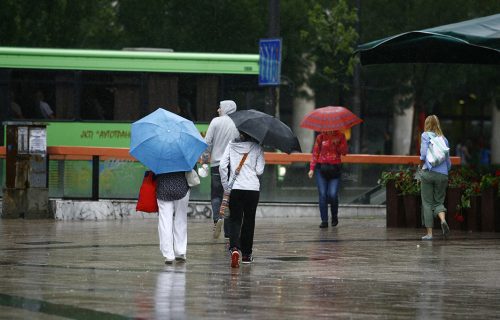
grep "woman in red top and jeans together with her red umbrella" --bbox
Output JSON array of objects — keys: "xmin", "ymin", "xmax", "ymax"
[{"xmin": 300, "ymin": 106, "xmax": 363, "ymax": 228}]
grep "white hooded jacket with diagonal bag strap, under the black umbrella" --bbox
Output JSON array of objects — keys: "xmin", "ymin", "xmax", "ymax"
[{"xmin": 219, "ymin": 139, "xmax": 266, "ymax": 191}]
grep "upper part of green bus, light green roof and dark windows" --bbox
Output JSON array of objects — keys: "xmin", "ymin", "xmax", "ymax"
[{"xmin": 0, "ymin": 47, "xmax": 264, "ymax": 126}]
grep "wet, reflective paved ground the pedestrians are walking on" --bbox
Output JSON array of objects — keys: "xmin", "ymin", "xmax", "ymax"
[{"xmin": 0, "ymin": 217, "xmax": 500, "ymax": 319}]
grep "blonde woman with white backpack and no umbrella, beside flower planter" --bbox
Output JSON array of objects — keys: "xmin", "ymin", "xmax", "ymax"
[{"xmin": 420, "ymin": 115, "xmax": 451, "ymax": 240}]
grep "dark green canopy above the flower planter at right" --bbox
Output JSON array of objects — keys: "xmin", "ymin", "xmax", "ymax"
[{"xmin": 356, "ymin": 14, "xmax": 500, "ymax": 65}]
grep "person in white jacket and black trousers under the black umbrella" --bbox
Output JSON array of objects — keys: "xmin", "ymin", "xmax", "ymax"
[{"xmin": 219, "ymin": 132, "xmax": 265, "ymax": 268}]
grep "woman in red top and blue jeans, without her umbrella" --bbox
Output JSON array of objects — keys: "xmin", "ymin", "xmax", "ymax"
[{"xmin": 308, "ymin": 130, "xmax": 348, "ymax": 228}]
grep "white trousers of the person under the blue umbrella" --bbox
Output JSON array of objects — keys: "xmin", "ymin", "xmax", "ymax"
[{"xmin": 157, "ymin": 190, "xmax": 190, "ymax": 260}]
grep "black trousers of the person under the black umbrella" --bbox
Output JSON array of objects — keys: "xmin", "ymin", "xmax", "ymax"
[{"xmin": 229, "ymin": 189, "xmax": 260, "ymax": 255}]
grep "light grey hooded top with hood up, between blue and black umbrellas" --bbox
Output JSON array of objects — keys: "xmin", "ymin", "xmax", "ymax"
[{"xmin": 205, "ymin": 100, "xmax": 239, "ymax": 167}]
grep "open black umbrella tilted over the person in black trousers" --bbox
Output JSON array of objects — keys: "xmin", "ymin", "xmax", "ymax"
[{"xmin": 229, "ymin": 109, "xmax": 302, "ymax": 153}]
